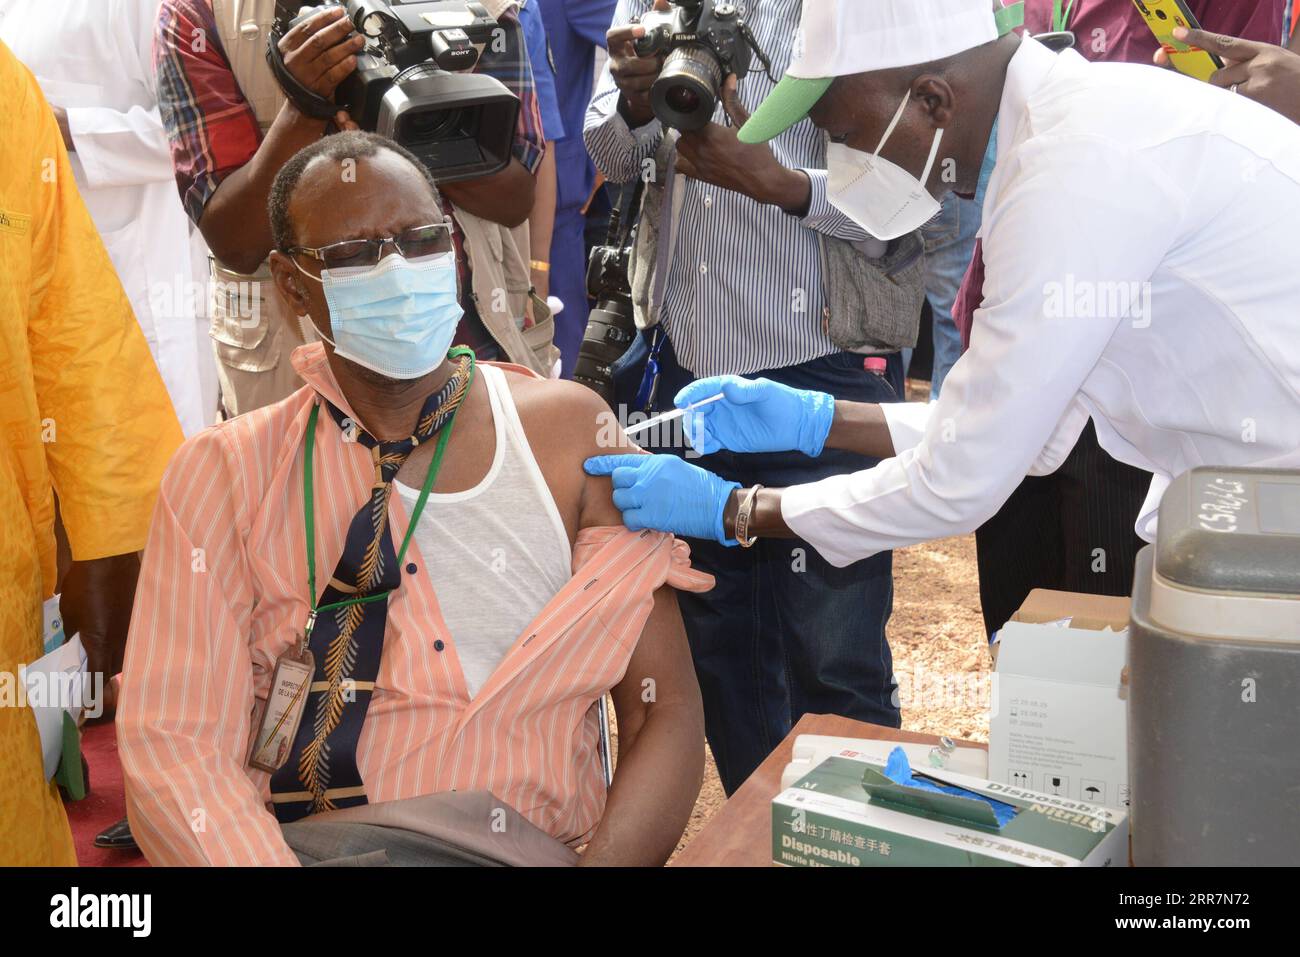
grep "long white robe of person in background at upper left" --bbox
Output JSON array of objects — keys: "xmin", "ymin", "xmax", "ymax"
[{"xmin": 0, "ymin": 0, "xmax": 215, "ymax": 436}]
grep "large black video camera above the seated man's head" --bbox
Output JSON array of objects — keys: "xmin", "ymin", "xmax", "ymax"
[{"xmin": 267, "ymin": 0, "xmax": 519, "ymax": 182}]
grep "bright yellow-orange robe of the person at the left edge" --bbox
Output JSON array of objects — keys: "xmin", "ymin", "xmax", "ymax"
[{"xmin": 0, "ymin": 43, "xmax": 181, "ymax": 865}]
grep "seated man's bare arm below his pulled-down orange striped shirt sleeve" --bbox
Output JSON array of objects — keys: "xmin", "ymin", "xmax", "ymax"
[{"xmin": 580, "ymin": 586, "xmax": 705, "ymax": 867}]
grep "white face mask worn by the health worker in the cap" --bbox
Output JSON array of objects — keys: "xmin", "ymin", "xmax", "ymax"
[{"xmin": 826, "ymin": 91, "xmax": 944, "ymax": 241}]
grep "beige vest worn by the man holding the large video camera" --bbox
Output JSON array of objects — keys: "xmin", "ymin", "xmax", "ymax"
[{"xmin": 211, "ymin": 0, "xmax": 559, "ymax": 376}]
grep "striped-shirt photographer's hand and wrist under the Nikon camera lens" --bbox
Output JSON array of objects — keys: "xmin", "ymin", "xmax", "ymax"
[{"xmin": 677, "ymin": 75, "xmax": 813, "ymax": 215}]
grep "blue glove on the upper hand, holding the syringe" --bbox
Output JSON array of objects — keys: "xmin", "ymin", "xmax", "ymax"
[{"xmin": 673, "ymin": 376, "xmax": 835, "ymax": 458}]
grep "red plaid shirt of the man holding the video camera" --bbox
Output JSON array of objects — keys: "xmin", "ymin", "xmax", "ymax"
[{"xmin": 153, "ymin": 0, "xmax": 546, "ymax": 224}]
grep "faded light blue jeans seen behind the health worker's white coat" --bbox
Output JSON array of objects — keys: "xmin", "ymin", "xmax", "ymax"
[{"xmin": 904, "ymin": 192, "xmax": 983, "ymax": 399}]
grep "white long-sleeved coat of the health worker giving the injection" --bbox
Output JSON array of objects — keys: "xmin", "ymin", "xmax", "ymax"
[{"xmin": 781, "ymin": 40, "xmax": 1300, "ymax": 566}]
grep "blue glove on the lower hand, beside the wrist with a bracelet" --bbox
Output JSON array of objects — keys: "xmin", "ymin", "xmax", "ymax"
[{"xmin": 584, "ymin": 455, "xmax": 740, "ymax": 545}]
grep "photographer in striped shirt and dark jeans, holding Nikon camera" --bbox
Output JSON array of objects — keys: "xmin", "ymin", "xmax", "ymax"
[{"xmin": 585, "ymin": 0, "xmax": 919, "ymax": 793}]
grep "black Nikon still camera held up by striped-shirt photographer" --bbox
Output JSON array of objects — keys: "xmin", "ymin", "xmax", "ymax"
[{"xmin": 634, "ymin": 0, "xmax": 771, "ymax": 131}]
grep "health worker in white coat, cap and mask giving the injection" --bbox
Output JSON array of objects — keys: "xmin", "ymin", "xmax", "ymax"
[{"xmin": 586, "ymin": 0, "xmax": 1300, "ymax": 564}]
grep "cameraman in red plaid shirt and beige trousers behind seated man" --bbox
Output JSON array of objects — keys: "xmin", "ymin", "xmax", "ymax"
[{"xmin": 155, "ymin": 0, "xmax": 543, "ymax": 416}]
